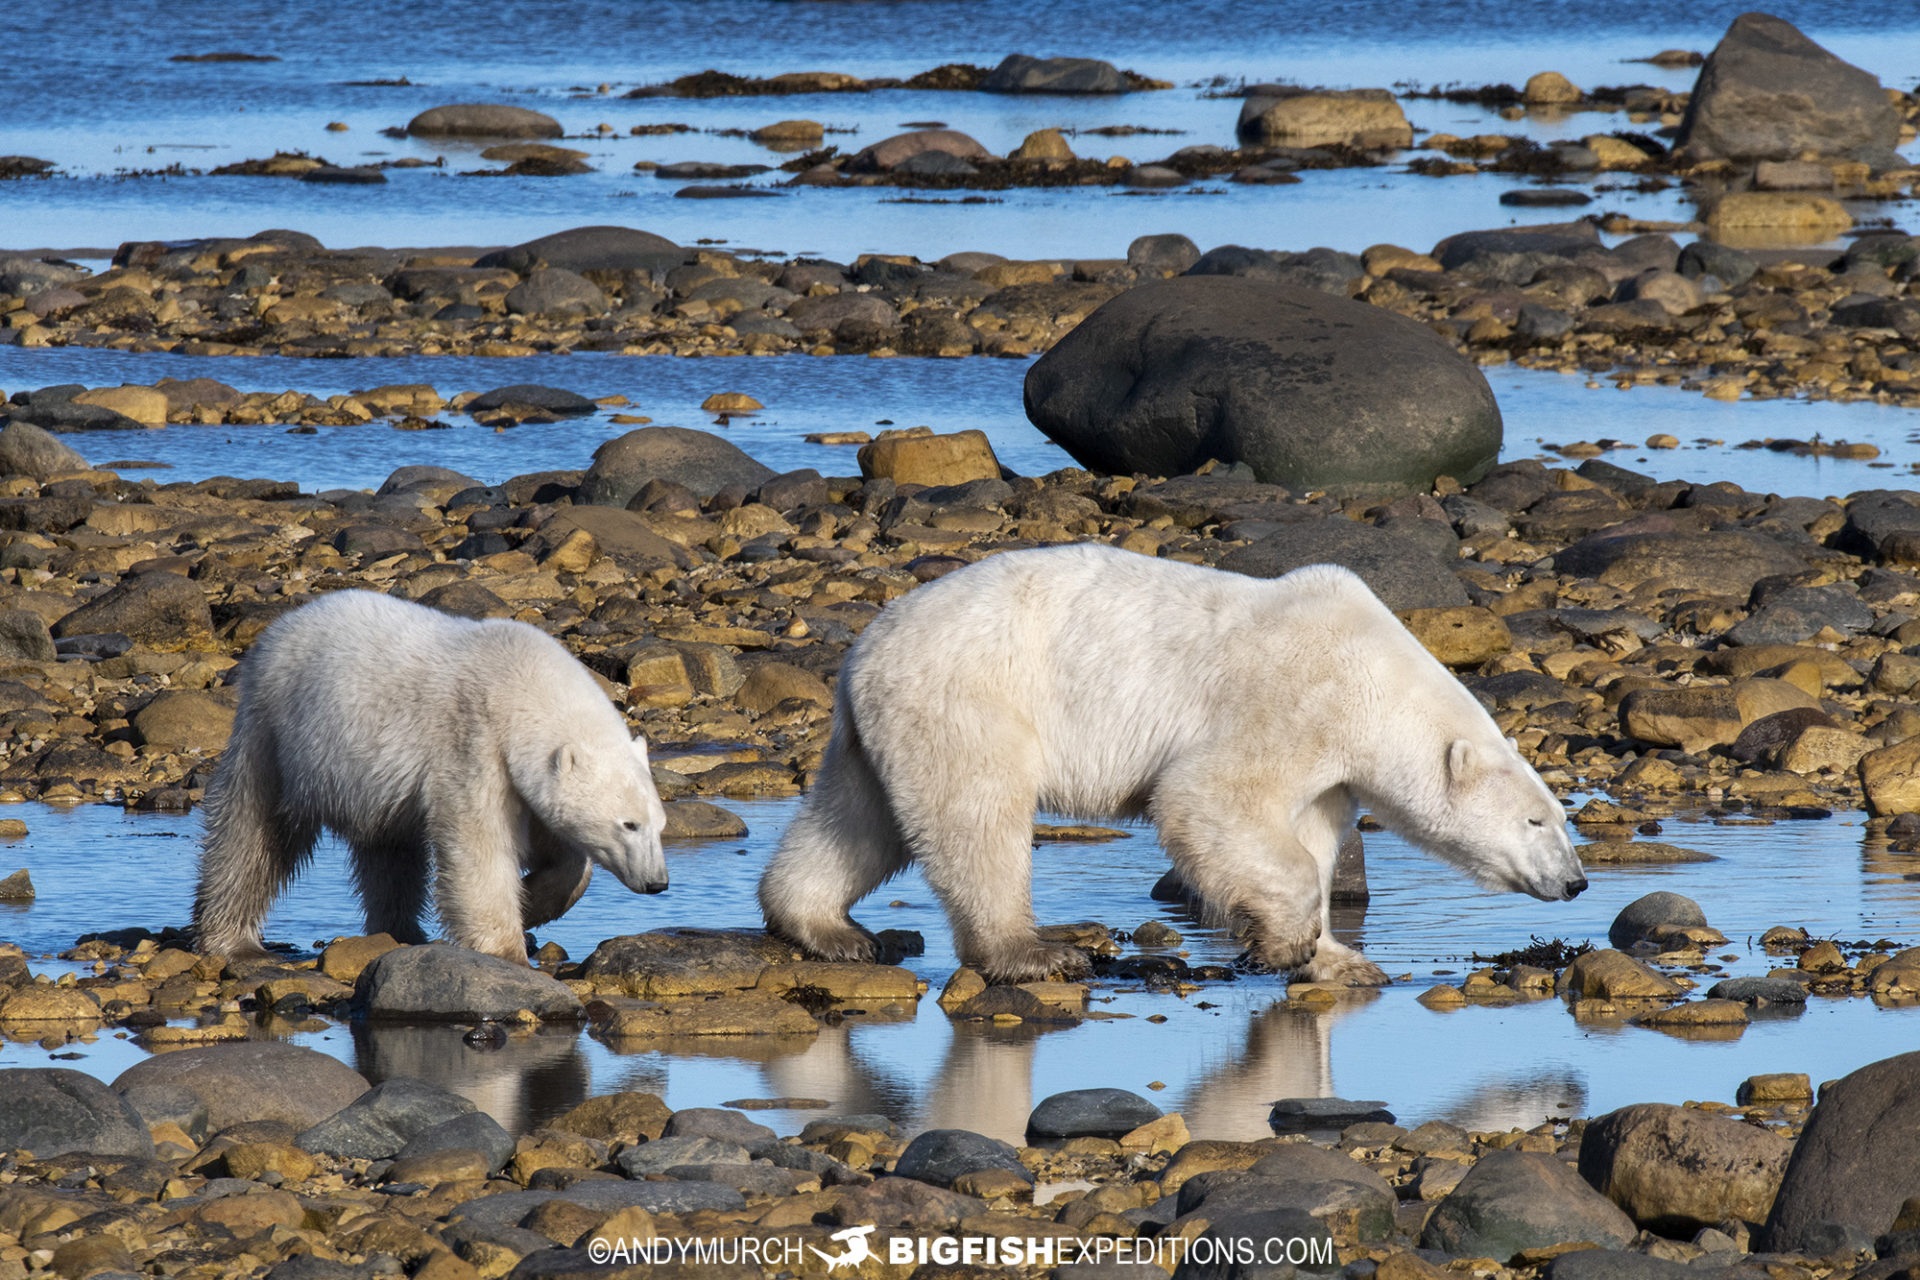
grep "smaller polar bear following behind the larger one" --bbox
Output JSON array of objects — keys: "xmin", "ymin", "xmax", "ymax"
[{"xmin": 194, "ymin": 591, "xmax": 666, "ymax": 963}]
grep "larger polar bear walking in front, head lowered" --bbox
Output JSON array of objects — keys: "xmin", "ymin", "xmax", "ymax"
[{"xmin": 760, "ymin": 545, "xmax": 1586, "ymax": 983}]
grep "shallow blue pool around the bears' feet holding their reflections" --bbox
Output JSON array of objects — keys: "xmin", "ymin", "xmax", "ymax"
[{"xmin": 0, "ymin": 800, "xmax": 1920, "ymax": 1142}]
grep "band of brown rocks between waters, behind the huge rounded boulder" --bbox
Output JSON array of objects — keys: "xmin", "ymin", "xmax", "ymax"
[{"xmin": 0, "ymin": 221, "xmax": 1920, "ymax": 422}]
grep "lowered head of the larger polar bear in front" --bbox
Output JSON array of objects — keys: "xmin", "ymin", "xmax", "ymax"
[{"xmin": 1430, "ymin": 737, "xmax": 1586, "ymax": 902}]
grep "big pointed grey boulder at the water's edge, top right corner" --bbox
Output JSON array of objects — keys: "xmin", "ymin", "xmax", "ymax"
[{"xmin": 1674, "ymin": 13, "xmax": 1901, "ymax": 159}]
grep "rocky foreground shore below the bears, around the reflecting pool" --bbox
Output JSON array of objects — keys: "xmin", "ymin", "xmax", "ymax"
[{"xmin": 0, "ymin": 929, "xmax": 1920, "ymax": 1280}]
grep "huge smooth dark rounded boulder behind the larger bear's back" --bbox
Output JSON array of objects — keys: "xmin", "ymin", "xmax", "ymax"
[{"xmin": 1025, "ymin": 276, "xmax": 1501, "ymax": 495}]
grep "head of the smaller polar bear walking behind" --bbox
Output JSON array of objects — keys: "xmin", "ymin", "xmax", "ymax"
[{"xmin": 541, "ymin": 737, "xmax": 666, "ymax": 894}]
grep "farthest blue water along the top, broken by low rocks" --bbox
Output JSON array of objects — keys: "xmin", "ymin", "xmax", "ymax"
[{"xmin": 0, "ymin": 0, "xmax": 1920, "ymax": 259}]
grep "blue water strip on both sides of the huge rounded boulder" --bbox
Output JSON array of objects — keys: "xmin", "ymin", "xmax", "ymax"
[{"xmin": 0, "ymin": 347, "xmax": 1920, "ymax": 495}]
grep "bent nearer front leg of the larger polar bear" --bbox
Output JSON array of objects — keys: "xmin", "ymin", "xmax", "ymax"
[{"xmin": 1150, "ymin": 785, "xmax": 1346, "ymax": 971}]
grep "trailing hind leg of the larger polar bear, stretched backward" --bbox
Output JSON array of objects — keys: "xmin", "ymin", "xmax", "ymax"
[{"xmin": 760, "ymin": 725, "xmax": 908, "ymax": 960}]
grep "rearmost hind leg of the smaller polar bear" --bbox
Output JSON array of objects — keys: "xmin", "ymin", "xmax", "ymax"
[{"xmin": 194, "ymin": 720, "xmax": 319, "ymax": 956}]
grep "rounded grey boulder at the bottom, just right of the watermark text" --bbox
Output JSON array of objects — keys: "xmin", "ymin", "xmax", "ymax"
[{"xmin": 1421, "ymin": 1151, "xmax": 1638, "ymax": 1263}]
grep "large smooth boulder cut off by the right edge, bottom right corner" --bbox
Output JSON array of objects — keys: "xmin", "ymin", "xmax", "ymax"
[{"xmin": 1766, "ymin": 1054, "xmax": 1920, "ymax": 1253}]
